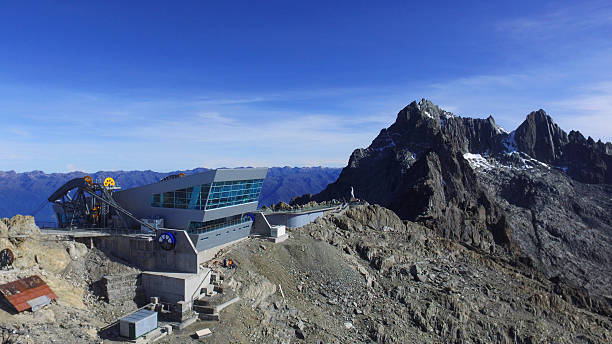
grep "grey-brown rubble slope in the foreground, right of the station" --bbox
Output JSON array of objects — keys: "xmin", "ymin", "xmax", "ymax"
[{"xmin": 164, "ymin": 205, "xmax": 612, "ymax": 343}]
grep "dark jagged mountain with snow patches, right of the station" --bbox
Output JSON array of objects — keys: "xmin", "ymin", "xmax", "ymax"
[{"xmin": 300, "ymin": 100, "xmax": 612, "ymax": 294}]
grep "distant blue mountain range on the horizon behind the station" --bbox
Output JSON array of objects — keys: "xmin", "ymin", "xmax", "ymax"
[{"xmin": 0, "ymin": 167, "xmax": 341, "ymax": 225}]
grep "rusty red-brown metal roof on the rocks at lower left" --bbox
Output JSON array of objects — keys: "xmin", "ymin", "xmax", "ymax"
[{"xmin": 0, "ymin": 275, "xmax": 57, "ymax": 312}]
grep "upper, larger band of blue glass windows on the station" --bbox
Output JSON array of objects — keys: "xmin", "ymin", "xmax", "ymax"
[{"xmin": 151, "ymin": 179, "xmax": 263, "ymax": 210}]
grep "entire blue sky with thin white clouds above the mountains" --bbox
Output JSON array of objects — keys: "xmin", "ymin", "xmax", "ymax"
[{"xmin": 0, "ymin": 1, "xmax": 612, "ymax": 172}]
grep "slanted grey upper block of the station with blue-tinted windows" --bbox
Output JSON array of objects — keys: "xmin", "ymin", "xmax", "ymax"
[{"xmin": 113, "ymin": 168, "xmax": 268, "ymax": 252}]
